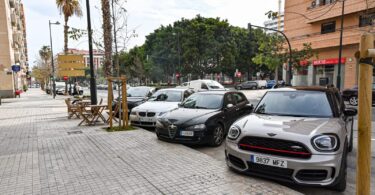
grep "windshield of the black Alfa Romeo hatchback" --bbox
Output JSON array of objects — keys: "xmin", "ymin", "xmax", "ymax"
[{"xmin": 181, "ymin": 94, "xmax": 224, "ymax": 109}]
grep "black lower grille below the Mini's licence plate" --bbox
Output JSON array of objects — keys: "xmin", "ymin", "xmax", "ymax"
[{"xmin": 247, "ymin": 162, "xmax": 293, "ymax": 182}]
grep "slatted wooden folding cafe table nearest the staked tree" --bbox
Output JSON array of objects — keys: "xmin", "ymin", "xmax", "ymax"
[{"xmin": 78, "ymin": 105, "xmax": 108, "ymax": 126}]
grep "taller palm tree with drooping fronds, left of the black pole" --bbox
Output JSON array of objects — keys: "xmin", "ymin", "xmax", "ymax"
[{"xmin": 56, "ymin": 0, "xmax": 82, "ymax": 53}]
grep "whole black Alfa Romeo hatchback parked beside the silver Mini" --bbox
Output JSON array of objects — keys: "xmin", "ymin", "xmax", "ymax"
[{"xmin": 156, "ymin": 91, "xmax": 253, "ymax": 146}]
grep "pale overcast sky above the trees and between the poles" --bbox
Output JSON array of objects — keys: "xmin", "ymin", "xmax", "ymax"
[{"xmin": 23, "ymin": 0, "xmax": 284, "ymax": 65}]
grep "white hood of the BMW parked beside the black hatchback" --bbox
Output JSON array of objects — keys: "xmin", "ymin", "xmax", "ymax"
[{"xmin": 133, "ymin": 101, "xmax": 180, "ymax": 112}]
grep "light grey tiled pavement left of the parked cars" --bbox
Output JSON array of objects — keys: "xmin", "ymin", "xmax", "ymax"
[{"xmin": 0, "ymin": 89, "xmax": 297, "ymax": 195}]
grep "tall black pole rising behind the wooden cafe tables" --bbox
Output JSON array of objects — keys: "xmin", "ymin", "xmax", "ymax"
[{"xmin": 86, "ymin": 0, "xmax": 98, "ymax": 106}]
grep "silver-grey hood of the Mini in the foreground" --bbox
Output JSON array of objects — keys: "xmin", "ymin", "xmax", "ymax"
[{"xmin": 236, "ymin": 114, "xmax": 341, "ymax": 138}]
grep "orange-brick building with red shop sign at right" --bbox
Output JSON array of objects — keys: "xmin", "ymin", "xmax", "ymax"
[{"xmin": 284, "ymin": 0, "xmax": 375, "ymax": 89}]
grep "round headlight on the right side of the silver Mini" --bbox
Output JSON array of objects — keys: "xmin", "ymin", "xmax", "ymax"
[{"xmin": 312, "ymin": 134, "xmax": 340, "ymax": 152}]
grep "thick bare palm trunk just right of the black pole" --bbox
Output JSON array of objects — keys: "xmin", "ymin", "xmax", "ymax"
[{"xmin": 101, "ymin": 0, "xmax": 112, "ymax": 77}]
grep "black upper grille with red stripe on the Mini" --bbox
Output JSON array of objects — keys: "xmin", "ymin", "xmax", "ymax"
[{"xmin": 238, "ymin": 136, "xmax": 311, "ymax": 159}]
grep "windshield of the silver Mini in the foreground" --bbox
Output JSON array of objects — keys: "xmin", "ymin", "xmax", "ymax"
[{"xmin": 255, "ymin": 91, "xmax": 333, "ymax": 118}]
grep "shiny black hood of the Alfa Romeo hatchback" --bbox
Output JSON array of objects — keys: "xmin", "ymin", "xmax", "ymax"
[{"xmin": 160, "ymin": 108, "xmax": 220, "ymax": 126}]
